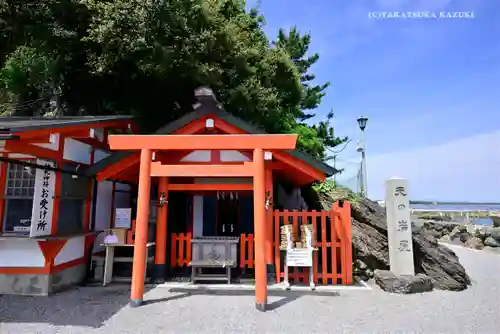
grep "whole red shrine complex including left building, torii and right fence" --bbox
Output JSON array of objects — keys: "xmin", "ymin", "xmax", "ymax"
[{"xmin": 0, "ymin": 88, "xmax": 352, "ymax": 310}]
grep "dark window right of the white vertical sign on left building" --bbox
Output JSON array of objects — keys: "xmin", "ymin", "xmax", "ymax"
[{"xmin": 57, "ymin": 164, "xmax": 91, "ymax": 234}]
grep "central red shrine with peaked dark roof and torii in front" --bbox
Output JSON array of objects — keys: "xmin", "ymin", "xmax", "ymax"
[{"xmin": 86, "ymin": 87, "xmax": 349, "ymax": 310}]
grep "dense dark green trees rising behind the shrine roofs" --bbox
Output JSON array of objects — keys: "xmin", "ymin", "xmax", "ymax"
[{"xmin": 0, "ymin": 0, "xmax": 345, "ymax": 159}]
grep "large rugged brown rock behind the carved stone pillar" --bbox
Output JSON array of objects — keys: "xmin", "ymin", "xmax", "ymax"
[{"xmin": 310, "ymin": 190, "xmax": 471, "ymax": 291}]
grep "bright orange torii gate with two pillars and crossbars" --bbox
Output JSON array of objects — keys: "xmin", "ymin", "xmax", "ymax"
[{"xmin": 109, "ymin": 134, "xmax": 297, "ymax": 311}]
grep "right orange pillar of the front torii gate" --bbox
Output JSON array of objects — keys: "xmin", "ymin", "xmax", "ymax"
[{"xmin": 253, "ymin": 148, "xmax": 267, "ymax": 311}]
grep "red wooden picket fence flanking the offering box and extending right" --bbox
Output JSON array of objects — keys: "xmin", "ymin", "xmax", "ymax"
[{"xmin": 170, "ymin": 202, "xmax": 352, "ymax": 285}]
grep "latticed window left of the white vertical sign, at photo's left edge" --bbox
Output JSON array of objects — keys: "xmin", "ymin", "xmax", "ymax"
[{"xmin": 3, "ymin": 163, "xmax": 36, "ymax": 234}]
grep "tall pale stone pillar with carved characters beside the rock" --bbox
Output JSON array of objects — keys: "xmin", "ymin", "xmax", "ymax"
[{"xmin": 385, "ymin": 177, "xmax": 415, "ymax": 275}]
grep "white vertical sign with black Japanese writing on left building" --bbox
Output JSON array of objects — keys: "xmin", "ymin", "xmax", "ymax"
[{"xmin": 30, "ymin": 159, "xmax": 56, "ymax": 237}]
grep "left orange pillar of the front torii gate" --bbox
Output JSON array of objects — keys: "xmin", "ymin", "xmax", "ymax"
[{"xmin": 130, "ymin": 149, "xmax": 152, "ymax": 307}]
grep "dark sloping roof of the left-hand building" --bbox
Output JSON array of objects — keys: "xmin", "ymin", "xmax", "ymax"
[{"xmin": 0, "ymin": 115, "xmax": 133, "ymax": 133}]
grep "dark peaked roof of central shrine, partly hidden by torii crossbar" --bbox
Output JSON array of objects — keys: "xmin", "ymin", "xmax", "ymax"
[{"xmin": 85, "ymin": 88, "xmax": 337, "ymax": 176}]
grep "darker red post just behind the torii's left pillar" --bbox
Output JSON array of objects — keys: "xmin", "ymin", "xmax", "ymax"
[{"xmin": 153, "ymin": 176, "xmax": 168, "ymax": 283}]
